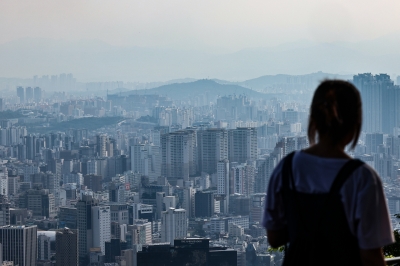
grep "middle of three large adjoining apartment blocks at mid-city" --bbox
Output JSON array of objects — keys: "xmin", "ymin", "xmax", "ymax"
[{"xmin": 197, "ymin": 128, "xmax": 228, "ymax": 175}]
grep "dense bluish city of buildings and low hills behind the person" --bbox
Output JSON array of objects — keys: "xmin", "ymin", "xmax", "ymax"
[{"xmin": 0, "ymin": 72, "xmax": 400, "ymax": 266}]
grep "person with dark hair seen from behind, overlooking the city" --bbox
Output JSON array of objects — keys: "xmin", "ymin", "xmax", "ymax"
[{"xmin": 262, "ymin": 80, "xmax": 394, "ymax": 266}]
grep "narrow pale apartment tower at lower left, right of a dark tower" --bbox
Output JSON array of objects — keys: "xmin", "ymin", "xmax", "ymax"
[{"xmin": 92, "ymin": 206, "xmax": 111, "ymax": 255}]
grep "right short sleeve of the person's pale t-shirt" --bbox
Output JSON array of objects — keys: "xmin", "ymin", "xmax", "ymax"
[{"xmin": 343, "ymin": 165, "xmax": 394, "ymax": 249}]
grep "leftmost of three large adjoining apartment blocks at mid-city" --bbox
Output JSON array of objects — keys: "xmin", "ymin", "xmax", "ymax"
[{"xmin": 161, "ymin": 130, "xmax": 197, "ymax": 180}]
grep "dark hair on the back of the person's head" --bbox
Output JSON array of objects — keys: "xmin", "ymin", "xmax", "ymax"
[{"xmin": 307, "ymin": 80, "xmax": 362, "ymax": 149}]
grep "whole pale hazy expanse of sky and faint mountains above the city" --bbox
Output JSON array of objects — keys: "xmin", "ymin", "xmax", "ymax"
[{"xmin": 0, "ymin": 0, "xmax": 400, "ymax": 82}]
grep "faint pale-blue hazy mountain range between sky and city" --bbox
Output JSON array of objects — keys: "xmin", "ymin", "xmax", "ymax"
[{"xmin": 0, "ymin": 34, "xmax": 400, "ymax": 82}]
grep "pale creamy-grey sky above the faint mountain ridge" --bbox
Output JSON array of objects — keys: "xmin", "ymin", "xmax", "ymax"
[{"xmin": 0, "ymin": 0, "xmax": 400, "ymax": 52}]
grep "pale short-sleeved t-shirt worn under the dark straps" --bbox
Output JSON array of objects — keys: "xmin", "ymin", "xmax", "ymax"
[{"xmin": 262, "ymin": 151, "xmax": 394, "ymax": 249}]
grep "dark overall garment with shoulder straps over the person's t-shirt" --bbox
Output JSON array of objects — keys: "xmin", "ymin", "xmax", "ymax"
[{"xmin": 282, "ymin": 152, "xmax": 364, "ymax": 266}]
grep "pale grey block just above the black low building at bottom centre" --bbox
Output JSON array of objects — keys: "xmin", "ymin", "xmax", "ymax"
[{"xmin": 161, "ymin": 208, "xmax": 187, "ymax": 244}]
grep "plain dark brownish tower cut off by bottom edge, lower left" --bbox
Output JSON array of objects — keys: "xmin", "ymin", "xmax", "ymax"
[{"xmin": 56, "ymin": 228, "xmax": 79, "ymax": 266}]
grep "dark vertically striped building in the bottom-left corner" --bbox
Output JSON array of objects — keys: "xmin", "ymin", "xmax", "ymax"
[{"xmin": 0, "ymin": 225, "xmax": 37, "ymax": 266}]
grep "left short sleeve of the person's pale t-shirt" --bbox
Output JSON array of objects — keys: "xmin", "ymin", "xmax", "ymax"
[{"xmin": 261, "ymin": 160, "xmax": 286, "ymax": 230}]
